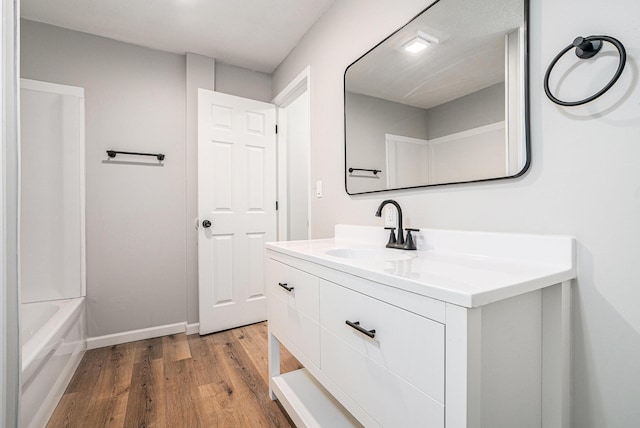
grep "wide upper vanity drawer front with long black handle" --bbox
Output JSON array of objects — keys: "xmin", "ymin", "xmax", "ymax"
[{"xmin": 320, "ymin": 280, "xmax": 445, "ymax": 403}]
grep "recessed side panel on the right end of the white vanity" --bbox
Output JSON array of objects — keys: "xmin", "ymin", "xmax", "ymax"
[{"xmin": 481, "ymin": 290, "xmax": 542, "ymax": 428}]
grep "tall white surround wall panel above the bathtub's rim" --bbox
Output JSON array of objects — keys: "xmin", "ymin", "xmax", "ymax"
[{"xmin": 20, "ymin": 79, "xmax": 86, "ymax": 303}]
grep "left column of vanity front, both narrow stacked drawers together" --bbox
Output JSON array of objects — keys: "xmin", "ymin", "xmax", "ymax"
[{"xmin": 266, "ymin": 259, "xmax": 320, "ymax": 367}]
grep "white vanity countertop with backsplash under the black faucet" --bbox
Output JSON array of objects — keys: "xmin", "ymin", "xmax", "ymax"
[{"xmin": 266, "ymin": 225, "xmax": 576, "ymax": 308}]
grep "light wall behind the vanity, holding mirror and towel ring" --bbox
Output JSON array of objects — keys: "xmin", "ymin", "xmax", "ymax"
[{"xmin": 273, "ymin": 0, "xmax": 640, "ymax": 428}]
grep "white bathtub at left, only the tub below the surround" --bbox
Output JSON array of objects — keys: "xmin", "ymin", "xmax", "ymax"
[{"xmin": 20, "ymin": 297, "xmax": 87, "ymax": 428}]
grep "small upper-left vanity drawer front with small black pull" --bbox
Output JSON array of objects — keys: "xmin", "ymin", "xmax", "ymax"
[{"xmin": 267, "ymin": 259, "xmax": 319, "ymax": 322}]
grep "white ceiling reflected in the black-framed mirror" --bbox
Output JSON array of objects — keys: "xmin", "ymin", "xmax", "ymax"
[{"xmin": 347, "ymin": 0, "xmax": 524, "ymax": 108}]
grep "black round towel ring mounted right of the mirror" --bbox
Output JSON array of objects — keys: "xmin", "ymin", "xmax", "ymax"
[{"xmin": 544, "ymin": 36, "xmax": 627, "ymax": 107}]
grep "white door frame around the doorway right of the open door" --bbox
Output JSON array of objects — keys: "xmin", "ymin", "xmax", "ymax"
[{"xmin": 271, "ymin": 65, "xmax": 312, "ymax": 241}]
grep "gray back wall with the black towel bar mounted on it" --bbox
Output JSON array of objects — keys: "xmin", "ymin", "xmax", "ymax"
[{"xmin": 21, "ymin": 20, "xmax": 271, "ymax": 337}]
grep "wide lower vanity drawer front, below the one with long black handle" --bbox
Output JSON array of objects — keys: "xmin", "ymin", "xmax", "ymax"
[{"xmin": 320, "ymin": 328, "xmax": 444, "ymax": 428}]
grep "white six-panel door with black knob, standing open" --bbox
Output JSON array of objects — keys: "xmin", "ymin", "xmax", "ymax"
[{"xmin": 198, "ymin": 89, "xmax": 276, "ymax": 334}]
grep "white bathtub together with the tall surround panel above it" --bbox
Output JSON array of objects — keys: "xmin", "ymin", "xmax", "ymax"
[{"xmin": 20, "ymin": 79, "xmax": 86, "ymax": 428}]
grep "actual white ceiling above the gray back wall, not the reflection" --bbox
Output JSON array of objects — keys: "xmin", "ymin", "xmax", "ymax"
[{"xmin": 20, "ymin": 0, "xmax": 334, "ymax": 73}]
